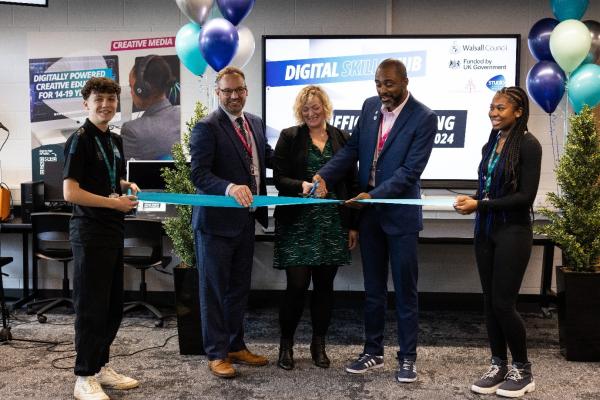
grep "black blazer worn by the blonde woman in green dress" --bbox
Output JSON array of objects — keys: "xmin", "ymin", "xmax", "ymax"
[{"xmin": 273, "ymin": 124, "xmax": 358, "ymax": 228}]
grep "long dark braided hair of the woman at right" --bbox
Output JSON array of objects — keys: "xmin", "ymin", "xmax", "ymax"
[{"xmin": 475, "ymin": 86, "xmax": 529, "ymax": 232}]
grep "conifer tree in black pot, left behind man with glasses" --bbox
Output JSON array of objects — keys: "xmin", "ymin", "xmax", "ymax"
[{"xmin": 162, "ymin": 102, "xmax": 207, "ymax": 354}]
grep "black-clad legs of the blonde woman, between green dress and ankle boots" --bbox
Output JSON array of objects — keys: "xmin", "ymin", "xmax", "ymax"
[{"xmin": 279, "ymin": 265, "xmax": 338, "ymax": 339}]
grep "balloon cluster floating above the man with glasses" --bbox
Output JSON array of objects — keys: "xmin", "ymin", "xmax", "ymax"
[{"xmin": 175, "ymin": 0, "xmax": 256, "ymax": 75}]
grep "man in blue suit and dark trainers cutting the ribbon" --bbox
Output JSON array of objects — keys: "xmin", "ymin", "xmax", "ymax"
[{"xmin": 314, "ymin": 59, "xmax": 437, "ymax": 382}]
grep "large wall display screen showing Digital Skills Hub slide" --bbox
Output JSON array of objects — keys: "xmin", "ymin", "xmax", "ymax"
[{"xmin": 263, "ymin": 35, "xmax": 520, "ymax": 187}]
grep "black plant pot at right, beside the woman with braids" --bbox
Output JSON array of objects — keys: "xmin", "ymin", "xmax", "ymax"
[{"xmin": 556, "ymin": 266, "xmax": 600, "ymax": 361}]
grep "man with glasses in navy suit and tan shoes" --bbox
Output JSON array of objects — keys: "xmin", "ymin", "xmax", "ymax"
[{"xmin": 191, "ymin": 67, "xmax": 272, "ymax": 378}]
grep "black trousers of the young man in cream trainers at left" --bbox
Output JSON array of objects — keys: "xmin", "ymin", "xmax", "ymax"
[{"xmin": 72, "ymin": 244, "xmax": 123, "ymax": 376}]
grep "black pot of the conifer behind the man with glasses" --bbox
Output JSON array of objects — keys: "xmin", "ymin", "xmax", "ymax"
[{"xmin": 173, "ymin": 267, "xmax": 206, "ymax": 355}]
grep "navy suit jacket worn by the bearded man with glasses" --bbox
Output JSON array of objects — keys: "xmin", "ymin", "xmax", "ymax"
[{"xmin": 190, "ymin": 107, "xmax": 272, "ymax": 237}]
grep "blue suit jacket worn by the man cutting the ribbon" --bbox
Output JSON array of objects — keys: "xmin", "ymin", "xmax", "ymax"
[{"xmin": 319, "ymin": 94, "xmax": 437, "ymax": 235}]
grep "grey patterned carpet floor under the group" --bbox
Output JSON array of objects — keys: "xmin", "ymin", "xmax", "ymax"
[{"xmin": 0, "ymin": 308, "xmax": 600, "ymax": 400}]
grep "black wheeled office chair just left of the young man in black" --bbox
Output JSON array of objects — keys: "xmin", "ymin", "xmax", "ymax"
[{"xmin": 27, "ymin": 212, "xmax": 73, "ymax": 324}]
